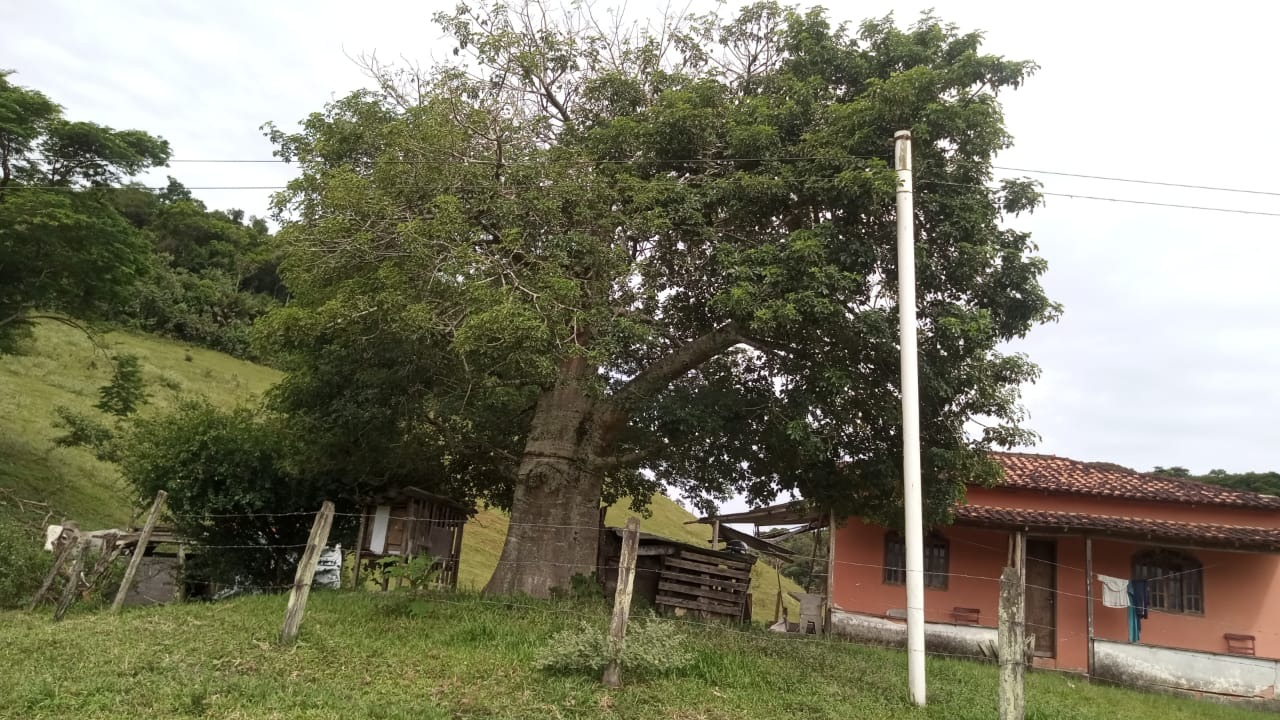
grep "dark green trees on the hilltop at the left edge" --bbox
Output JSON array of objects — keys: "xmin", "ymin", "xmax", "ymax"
[{"xmin": 0, "ymin": 72, "xmax": 285, "ymax": 356}]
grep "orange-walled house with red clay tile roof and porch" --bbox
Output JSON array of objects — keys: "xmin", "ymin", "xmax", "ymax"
[{"xmin": 721, "ymin": 454, "xmax": 1280, "ymax": 698}]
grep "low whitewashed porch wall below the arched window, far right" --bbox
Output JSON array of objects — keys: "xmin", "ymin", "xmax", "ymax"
[{"xmin": 1093, "ymin": 641, "xmax": 1280, "ymax": 700}]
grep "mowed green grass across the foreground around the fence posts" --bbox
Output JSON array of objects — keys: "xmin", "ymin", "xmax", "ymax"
[{"xmin": 0, "ymin": 592, "xmax": 1262, "ymax": 720}]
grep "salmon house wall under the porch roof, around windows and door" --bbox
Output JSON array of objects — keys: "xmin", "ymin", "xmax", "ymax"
[{"xmin": 832, "ymin": 512, "xmax": 1280, "ymax": 670}]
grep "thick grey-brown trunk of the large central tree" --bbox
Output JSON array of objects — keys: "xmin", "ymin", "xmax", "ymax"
[{"xmin": 485, "ymin": 357, "xmax": 602, "ymax": 597}]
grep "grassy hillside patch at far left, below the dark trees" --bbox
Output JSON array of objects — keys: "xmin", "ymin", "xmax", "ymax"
[{"xmin": 0, "ymin": 320, "xmax": 279, "ymax": 528}]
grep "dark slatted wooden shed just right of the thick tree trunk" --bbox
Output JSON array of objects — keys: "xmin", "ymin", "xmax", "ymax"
[{"xmin": 598, "ymin": 528, "xmax": 755, "ymax": 623}]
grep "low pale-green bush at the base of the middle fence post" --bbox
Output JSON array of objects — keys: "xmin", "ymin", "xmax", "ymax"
[{"xmin": 534, "ymin": 616, "xmax": 694, "ymax": 676}]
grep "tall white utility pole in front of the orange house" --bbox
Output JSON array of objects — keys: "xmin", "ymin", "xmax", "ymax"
[{"xmin": 893, "ymin": 129, "xmax": 925, "ymax": 707}]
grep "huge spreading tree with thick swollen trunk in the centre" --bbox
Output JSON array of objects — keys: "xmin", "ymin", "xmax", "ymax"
[{"xmin": 260, "ymin": 3, "xmax": 1057, "ymax": 594}]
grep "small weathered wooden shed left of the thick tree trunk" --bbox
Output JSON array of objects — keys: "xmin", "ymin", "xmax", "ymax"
[{"xmin": 356, "ymin": 487, "xmax": 471, "ymax": 588}]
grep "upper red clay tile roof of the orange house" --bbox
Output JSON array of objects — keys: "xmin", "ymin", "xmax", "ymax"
[{"xmin": 991, "ymin": 452, "xmax": 1280, "ymax": 510}]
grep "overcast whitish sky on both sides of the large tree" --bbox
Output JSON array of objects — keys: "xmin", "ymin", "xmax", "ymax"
[{"xmin": 0, "ymin": 0, "xmax": 1280, "ymax": 489}]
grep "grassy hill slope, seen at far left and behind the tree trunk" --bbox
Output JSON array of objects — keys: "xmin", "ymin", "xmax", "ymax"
[{"xmin": 0, "ymin": 322, "xmax": 799, "ymax": 620}]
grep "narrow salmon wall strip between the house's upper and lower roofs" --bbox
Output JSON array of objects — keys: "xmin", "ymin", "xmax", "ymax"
[{"xmin": 966, "ymin": 487, "xmax": 1280, "ymax": 528}]
